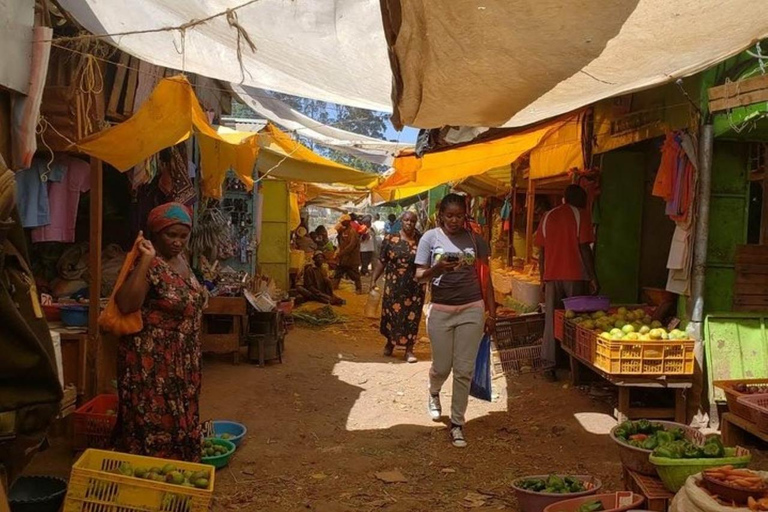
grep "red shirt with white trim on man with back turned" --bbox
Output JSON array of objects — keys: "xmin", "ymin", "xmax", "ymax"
[{"xmin": 536, "ymin": 204, "xmax": 595, "ymax": 281}]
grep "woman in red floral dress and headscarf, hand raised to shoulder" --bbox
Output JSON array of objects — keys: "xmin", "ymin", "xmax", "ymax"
[{"xmin": 115, "ymin": 203, "xmax": 206, "ymax": 462}]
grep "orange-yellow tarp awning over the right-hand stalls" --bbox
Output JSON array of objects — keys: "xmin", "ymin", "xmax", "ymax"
[{"xmin": 375, "ymin": 112, "xmax": 584, "ymax": 201}]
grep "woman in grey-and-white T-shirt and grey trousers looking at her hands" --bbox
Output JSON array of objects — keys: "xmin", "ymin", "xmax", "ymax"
[{"xmin": 416, "ymin": 194, "xmax": 496, "ymax": 448}]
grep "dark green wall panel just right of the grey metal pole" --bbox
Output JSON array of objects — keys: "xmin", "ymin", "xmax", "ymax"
[{"xmin": 704, "ymin": 140, "xmax": 749, "ymax": 312}]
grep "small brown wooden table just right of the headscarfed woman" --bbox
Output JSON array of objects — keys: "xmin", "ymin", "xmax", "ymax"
[{"xmin": 200, "ymin": 297, "xmax": 248, "ymax": 364}]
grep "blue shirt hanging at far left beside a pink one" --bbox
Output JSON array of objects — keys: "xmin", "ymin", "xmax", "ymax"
[{"xmin": 15, "ymin": 158, "xmax": 66, "ymax": 228}]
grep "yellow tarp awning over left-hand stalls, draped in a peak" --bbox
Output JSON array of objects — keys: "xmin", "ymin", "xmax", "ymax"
[{"xmin": 75, "ymin": 76, "xmax": 378, "ymax": 197}]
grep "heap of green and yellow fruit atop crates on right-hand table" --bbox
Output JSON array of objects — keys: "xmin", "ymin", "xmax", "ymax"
[{"xmin": 565, "ymin": 307, "xmax": 690, "ymax": 341}]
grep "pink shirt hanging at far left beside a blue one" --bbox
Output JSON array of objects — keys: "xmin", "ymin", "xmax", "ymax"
[{"xmin": 32, "ymin": 157, "xmax": 91, "ymax": 243}]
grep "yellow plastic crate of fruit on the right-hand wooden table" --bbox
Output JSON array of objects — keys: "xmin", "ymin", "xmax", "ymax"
[{"xmin": 595, "ymin": 337, "xmax": 694, "ymax": 375}]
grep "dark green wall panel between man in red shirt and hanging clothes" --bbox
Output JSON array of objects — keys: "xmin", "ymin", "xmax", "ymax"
[{"xmin": 595, "ymin": 151, "xmax": 645, "ymax": 304}]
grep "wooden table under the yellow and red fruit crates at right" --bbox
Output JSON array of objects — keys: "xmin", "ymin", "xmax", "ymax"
[{"xmin": 561, "ymin": 343, "xmax": 693, "ymax": 424}]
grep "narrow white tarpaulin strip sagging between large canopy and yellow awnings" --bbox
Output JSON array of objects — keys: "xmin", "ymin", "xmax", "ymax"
[{"xmin": 231, "ymin": 84, "xmax": 410, "ymax": 166}]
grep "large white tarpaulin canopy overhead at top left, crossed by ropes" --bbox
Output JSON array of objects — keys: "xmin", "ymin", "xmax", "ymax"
[{"xmin": 59, "ymin": 0, "xmax": 392, "ymax": 112}]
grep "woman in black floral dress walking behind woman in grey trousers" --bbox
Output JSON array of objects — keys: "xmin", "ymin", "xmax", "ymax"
[{"xmin": 371, "ymin": 212, "xmax": 424, "ymax": 363}]
